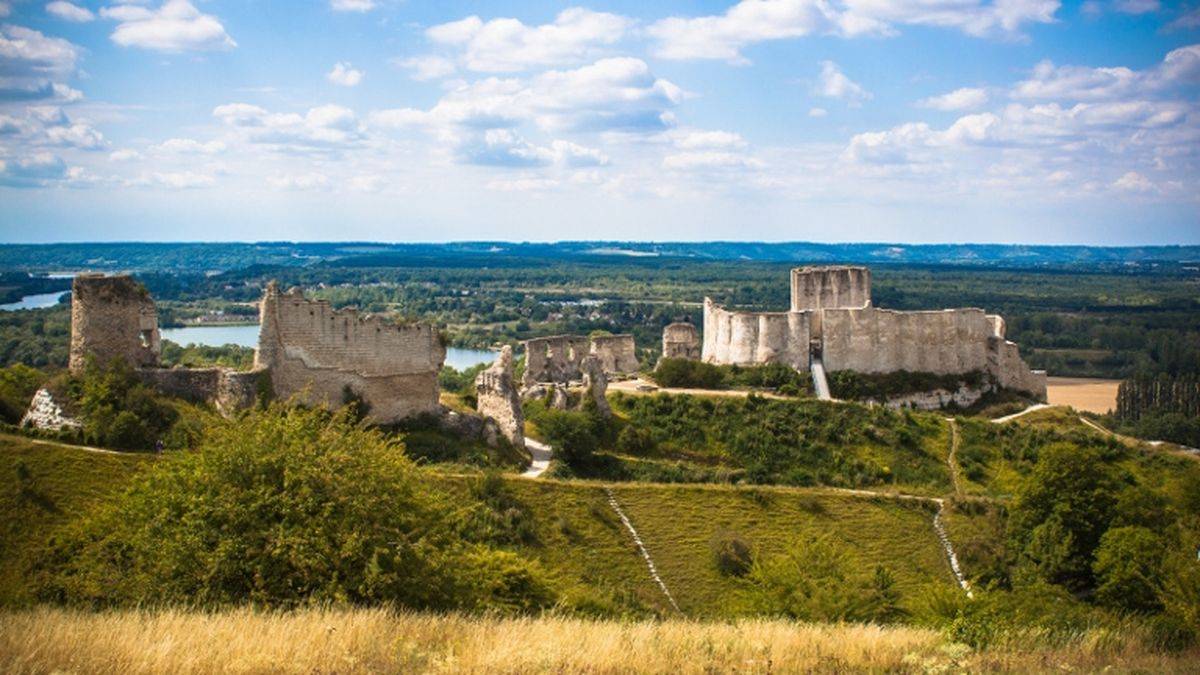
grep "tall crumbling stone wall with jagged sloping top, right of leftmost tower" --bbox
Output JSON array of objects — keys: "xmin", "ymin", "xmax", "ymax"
[{"xmin": 254, "ymin": 282, "xmax": 445, "ymax": 423}]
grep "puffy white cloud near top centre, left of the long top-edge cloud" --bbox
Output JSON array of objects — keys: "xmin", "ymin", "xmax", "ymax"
[{"xmin": 426, "ymin": 7, "xmax": 631, "ymax": 72}]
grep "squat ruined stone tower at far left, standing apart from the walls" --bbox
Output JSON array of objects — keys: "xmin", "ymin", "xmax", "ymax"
[{"xmin": 70, "ymin": 274, "xmax": 161, "ymax": 375}]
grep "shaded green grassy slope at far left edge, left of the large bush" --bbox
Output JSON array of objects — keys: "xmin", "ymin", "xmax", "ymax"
[{"xmin": 0, "ymin": 435, "xmax": 154, "ymax": 605}]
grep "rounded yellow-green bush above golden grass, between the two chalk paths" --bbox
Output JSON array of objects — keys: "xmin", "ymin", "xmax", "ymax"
[{"xmin": 745, "ymin": 536, "xmax": 904, "ymax": 622}]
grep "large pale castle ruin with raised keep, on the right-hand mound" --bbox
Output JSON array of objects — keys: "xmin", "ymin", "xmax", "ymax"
[{"xmin": 701, "ymin": 267, "xmax": 1045, "ymax": 400}]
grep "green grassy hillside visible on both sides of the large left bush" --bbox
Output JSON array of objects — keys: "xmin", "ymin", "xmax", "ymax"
[{"xmin": 0, "ymin": 436, "xmax": 952, "ymax": 616}]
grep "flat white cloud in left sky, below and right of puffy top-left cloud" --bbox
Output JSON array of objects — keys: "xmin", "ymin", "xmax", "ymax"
[{"xmin": 212, "ymin": 103, "xmax": 365, "ymax": 153}]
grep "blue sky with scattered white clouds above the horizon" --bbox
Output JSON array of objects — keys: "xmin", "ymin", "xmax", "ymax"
[{"xmin": 0, "ymin": 0, "xmax": 1200, "ymax": 245}]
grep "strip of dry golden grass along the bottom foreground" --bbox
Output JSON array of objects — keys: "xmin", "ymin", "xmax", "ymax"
[{"xmin": 0, "ymin": 609, "xmax": 1198, "ymax": 674}]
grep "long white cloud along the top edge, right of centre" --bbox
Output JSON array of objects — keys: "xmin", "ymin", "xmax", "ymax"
[{"xmin": 647, "ymin": 0, "xmax": 1060, "ymax": 62}]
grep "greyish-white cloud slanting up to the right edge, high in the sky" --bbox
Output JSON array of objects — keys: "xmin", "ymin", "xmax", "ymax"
[{"xmin": 1013, "ymin": 44, "xmax": 1200, "ymax": 101}]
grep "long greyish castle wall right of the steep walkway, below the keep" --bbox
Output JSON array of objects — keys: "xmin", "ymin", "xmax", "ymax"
[{"xmin": 821, "ymin": 307, "xmax": 991, "ymax": 375}]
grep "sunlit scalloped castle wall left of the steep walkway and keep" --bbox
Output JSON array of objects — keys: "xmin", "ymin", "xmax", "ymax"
[{"xmin": 702, "ymin": 298, "xmax": 811, "ymax": 371}]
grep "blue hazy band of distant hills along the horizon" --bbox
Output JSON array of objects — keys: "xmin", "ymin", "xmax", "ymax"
[{"xmin": 0, "ymin": 241, "xmax": 1200, "ymax": 273}]
